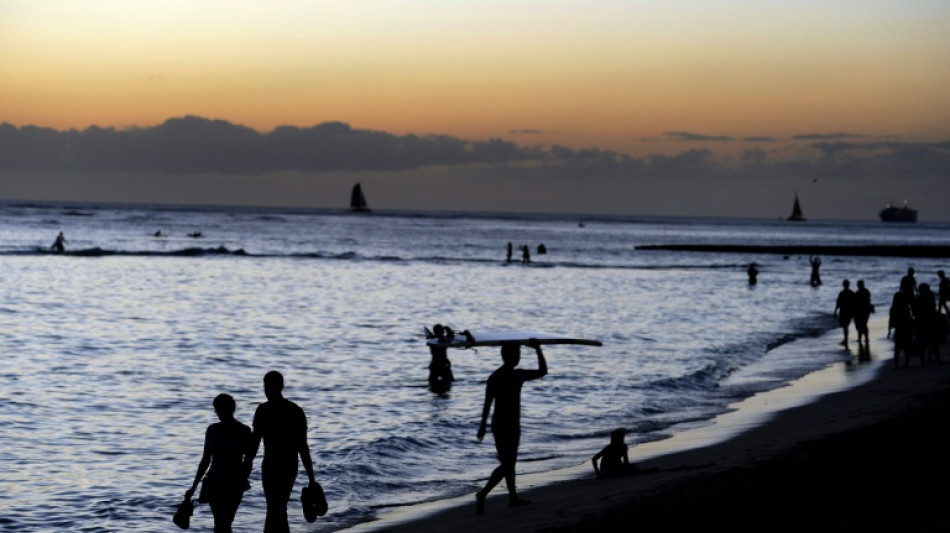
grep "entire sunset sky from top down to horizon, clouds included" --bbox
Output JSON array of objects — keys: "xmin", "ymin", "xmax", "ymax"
[{"xmin": 0, "ymin": 0, "xmax": 950, "ymax": 220}]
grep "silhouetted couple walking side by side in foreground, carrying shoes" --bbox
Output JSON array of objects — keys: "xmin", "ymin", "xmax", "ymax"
[{"xmin": 175, "ymin": 371, "xmax": 326, "ymax": 533}]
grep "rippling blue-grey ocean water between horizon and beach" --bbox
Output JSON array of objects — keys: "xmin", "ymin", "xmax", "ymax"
[{"xmin": 0, "ymin": 203, "xmax": 950, "ymax": 532}]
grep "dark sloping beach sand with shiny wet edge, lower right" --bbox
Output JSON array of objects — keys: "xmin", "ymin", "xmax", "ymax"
[{"xmin": 348, "ymin": 324, "xmax": 950, "ymax": 533}]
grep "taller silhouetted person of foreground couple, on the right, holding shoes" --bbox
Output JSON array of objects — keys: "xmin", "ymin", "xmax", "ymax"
[{"xmin": 245, "ymin": 370, "xmax": 316, "ymax": 533}]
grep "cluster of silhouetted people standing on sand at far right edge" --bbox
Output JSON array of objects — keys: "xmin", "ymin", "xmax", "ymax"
[{"xmin": 887, "ymin": 268, "xmax": 950, "ymax": 368}]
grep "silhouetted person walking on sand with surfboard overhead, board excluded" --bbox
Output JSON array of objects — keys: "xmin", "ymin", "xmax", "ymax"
[{"xmin": 475, "ymin": 339, "xmax": 548, "ymax": 514}]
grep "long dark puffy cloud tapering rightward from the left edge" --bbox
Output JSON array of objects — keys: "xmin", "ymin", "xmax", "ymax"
[{"xmin": 0, "ymin": 116, "xmax": 543, "ymax": 174}]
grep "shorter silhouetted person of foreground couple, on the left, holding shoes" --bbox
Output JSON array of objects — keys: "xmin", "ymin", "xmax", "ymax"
[{"xmin": 185, "ymin": 394, "xmax": 251, "ymax": 533}]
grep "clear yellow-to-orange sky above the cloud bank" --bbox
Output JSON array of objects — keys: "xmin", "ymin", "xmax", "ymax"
[{"xmin": 0, "ymin": 0, "xmax": 950, "ymax": 154}]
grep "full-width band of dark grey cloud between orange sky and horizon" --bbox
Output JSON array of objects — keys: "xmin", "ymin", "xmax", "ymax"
[{"xmin": 0, "ymin": 116, "xmax": 950, "ymax": 218}]
